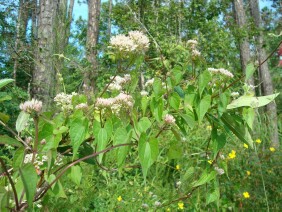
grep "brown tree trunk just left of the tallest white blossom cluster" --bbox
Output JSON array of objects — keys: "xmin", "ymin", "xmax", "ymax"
[{"xmin": 84, "ymin": 0, "xmax": 101, "ymax": 92}]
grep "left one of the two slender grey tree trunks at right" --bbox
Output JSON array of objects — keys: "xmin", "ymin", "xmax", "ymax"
[{"xmin": 234, "ymin": 0, "xmax": 254, "ymax": 85}]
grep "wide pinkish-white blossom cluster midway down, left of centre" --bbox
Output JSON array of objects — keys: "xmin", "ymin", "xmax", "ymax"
[{"xmin": 96, "ymin": 93, "xmax": 134, "ymax": 114}]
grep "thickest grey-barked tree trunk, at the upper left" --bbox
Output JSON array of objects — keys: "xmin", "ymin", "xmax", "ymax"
[{"xmin": 32, "ymin": 0, "xmax": 58, "ymax": 110}]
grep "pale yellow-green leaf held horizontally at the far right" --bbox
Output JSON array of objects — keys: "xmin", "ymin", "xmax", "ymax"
[{"xmin": 227, "ymin": 93, "xmax": 279, "ymax": 110}]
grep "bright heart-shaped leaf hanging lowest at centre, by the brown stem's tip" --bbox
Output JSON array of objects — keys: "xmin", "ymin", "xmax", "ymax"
[{"xmin": 138, "ymin": 133, "xmax": 159, "ymax": 178}]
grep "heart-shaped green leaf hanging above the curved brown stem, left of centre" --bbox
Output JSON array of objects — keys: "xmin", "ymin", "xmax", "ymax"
[{"xmin": 69, "ymin": 118, "xmax": 88, "ymax": 158}]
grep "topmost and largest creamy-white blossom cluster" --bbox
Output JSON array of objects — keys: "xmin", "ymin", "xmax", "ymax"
[{"xmin": 109, "ymin": 31, "xmax": 150, "ymax": 52}]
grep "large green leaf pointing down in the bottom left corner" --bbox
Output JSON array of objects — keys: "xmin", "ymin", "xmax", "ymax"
[{"xmin": 20, "ymin": 164, "xmax": 37, "ymax": 207}]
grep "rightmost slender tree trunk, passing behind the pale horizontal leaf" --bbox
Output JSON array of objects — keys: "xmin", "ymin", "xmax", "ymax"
[{"xmin": 250, "ymin": 0, "xmax": 279, "ymax": 147}]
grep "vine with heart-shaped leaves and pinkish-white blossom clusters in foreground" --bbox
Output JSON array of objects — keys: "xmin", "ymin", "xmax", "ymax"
[{"xmin": 1, "ymin": 31, "xmax": 277, "ymax": 210}]
